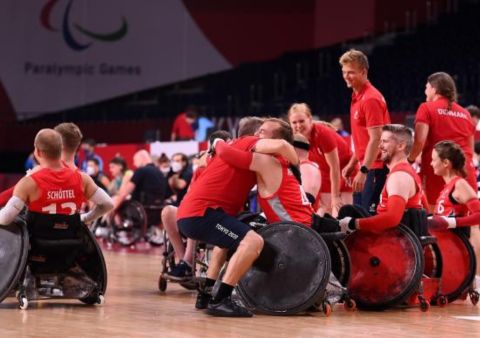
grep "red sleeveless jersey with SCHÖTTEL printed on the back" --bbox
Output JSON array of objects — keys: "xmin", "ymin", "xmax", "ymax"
[{"xmin": 28, "ymin": 168, "xmax": 85, "ymax": 215}]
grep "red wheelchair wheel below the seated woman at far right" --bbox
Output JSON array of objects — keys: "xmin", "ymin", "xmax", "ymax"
[{"xmin": 432, "ymin": 231, "xmax": 476, "ymax": 303}]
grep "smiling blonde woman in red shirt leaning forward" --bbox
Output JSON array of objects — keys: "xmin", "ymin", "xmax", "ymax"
[{"xmin": 288, "ymin": 103, "xmax": 352, "ymax": 216}]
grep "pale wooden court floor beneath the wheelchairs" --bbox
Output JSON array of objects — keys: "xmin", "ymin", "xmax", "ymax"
[{"xmin": 0, "ymin": 251, "xmax": 480, "ymax": 338}]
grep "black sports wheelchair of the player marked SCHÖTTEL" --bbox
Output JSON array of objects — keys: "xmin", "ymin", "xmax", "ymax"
[{"xmin": 0, "ymin": 212, "xmax": 107, "ymax": 309}]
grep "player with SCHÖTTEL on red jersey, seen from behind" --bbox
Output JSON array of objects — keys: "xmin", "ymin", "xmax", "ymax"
[{"xmin": 0, "ymin": 129, "xmax": 113, "ymax": 224}]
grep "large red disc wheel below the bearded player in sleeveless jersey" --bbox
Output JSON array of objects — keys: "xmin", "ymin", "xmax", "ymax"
[{"xmin": 345, "ymin": 225, "xmax": 424, "ymax": 310}]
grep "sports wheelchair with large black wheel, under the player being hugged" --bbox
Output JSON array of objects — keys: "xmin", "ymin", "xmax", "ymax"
[{"xmin": 237, "ymin": 214, "xmax": 356, "ymax": 316}]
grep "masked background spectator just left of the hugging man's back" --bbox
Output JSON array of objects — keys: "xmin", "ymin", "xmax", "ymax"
[{"xmin": 168, "ymin": 153, "xmax": 193, "ymax": 206}]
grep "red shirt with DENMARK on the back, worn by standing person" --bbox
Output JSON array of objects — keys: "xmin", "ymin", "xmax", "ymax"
[{"xmin": 415, "ymin": 97, "xmax": 477, "ymax": 204}]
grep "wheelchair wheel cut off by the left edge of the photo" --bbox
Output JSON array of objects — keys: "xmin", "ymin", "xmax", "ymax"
[{"xmin": 0, "ymin": 218, "xmax": 29, "ymax": 302}]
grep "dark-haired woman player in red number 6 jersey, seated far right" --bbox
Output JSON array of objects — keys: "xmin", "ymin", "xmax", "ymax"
[{"xmin": 428, "ymin": 141, "xmax": 480, "ymax": 230}]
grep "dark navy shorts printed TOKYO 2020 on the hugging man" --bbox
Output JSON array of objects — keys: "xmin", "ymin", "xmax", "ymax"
[{"xmin": 177, "ymin": 208, "xmax": 252, "ymax": 249}]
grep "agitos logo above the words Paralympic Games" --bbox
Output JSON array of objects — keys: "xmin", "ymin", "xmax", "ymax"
[{"xmin": 40, "ymin": 0, "xmax": 128, "ymax": 51}]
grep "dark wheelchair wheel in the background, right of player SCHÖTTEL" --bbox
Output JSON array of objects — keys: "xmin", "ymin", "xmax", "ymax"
[{"xmin": 112, "ymin": 200, "xmax": 147, "ymax": 246}]
